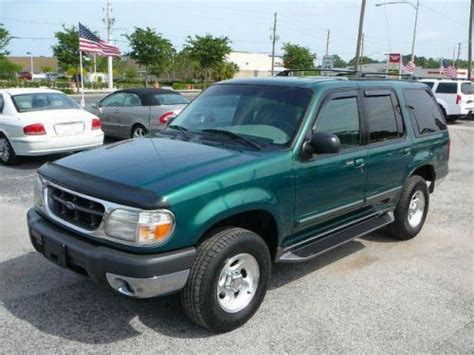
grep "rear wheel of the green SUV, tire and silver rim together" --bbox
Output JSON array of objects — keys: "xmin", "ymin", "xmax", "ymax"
[{"xmin": 390, "ymin": 175, "xmax": 430, "ymax": 240}]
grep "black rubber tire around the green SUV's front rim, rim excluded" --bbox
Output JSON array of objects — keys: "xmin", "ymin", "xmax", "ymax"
[{"xmin": 181, "ymin": 227, "xmax": 271, "ymax": 333}]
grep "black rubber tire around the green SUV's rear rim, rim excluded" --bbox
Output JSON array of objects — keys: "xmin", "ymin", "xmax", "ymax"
[{"xmin": 389, "ymin": 175, "xmax": 430, "ymax": 240}]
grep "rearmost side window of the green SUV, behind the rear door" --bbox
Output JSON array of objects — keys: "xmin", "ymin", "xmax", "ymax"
[{"xmin": 404, "ymin": 89, "xmax": 446, "ymax": 135}]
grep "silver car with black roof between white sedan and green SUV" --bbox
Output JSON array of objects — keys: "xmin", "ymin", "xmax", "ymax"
[{"xmin": 91, "ymin": 88, "xmax": 189, "ymax": 138}]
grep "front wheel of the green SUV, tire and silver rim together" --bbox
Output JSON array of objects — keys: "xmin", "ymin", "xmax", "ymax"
[{"xmin": 181, "ymin": 227, "xmax": 271, "ymax": 332}]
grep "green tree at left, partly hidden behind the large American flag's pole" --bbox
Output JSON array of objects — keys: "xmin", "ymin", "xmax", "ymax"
[{"xmin": 52, "ymin": 26, "xmax": 79, "ymax": 81}]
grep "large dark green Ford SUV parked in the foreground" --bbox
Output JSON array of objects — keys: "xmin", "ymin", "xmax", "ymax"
[{"xmin": 28, "ymin": 77, "xmax": 449, "ymax": 332}]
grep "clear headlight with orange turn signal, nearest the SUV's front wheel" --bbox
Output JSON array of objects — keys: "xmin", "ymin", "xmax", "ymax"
[{"xmin": 104, "ymin": 209, "xmax": 175, "ymax": 245}]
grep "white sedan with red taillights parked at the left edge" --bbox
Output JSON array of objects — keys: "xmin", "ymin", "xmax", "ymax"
[{"xmin": 0, "ymin": 89, "xmax": 104, "ymax": 165}]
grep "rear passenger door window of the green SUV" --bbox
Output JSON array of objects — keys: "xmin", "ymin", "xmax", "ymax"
[{"xmin": 365, "ymin": 95, "xmax": 403, "ymax": 143}]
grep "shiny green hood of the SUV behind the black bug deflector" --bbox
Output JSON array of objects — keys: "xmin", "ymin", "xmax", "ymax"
[{"xmin": 50, "ymin": 137, "xmax": 264, "ymax": 196}]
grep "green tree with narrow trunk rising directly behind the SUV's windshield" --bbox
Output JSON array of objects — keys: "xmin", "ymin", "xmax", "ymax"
[{"xmin": 184, "ymin": 34, "xmax": 231, "ymax": 86}]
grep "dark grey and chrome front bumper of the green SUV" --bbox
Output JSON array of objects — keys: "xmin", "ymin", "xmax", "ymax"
[{"xmin": 27, "ymin": 208, "xmax": 196, "ymax": 298}]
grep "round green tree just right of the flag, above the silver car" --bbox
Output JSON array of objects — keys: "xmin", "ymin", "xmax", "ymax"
[{"xmin": 125, "ymin": 27, "xmax": 174, "ymax": 85}]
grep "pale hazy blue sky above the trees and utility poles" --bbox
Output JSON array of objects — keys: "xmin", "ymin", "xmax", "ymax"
[{"xmin": 0, "ymin": 0, "xmax": 470, "ymax": 60}]
